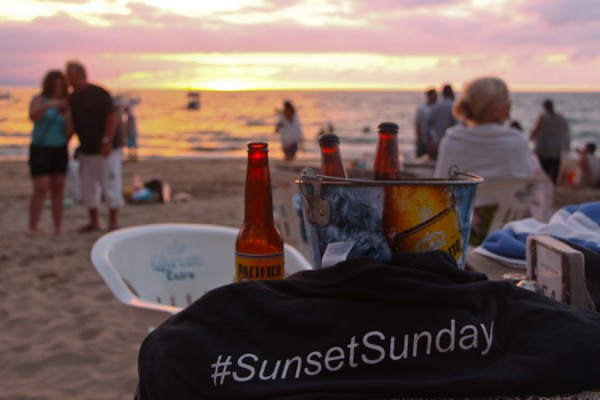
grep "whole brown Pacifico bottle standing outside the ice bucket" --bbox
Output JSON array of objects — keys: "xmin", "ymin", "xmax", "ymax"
[{"xmin": 235, "ymin": 142, "xmax": 284, "ymax": 282}]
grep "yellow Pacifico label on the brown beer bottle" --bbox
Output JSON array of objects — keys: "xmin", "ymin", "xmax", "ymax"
[{"xmin": 235, "ymin": 251, "xmax": 284, "ymax": 282}]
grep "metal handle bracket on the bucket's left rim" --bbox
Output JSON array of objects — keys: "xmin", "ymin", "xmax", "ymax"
[{"xmin": 300, "ymin": 168, "xmax": 331, "ymax": 226}]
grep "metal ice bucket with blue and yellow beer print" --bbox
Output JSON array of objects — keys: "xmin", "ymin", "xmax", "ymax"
[{"xmin": 296, "ymin": 168, "xmax": 483, "ymax": 268}]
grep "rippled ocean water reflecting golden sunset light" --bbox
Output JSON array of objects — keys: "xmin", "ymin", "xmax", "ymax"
[{"xmin": 0, "ymin": 87, "xmax": 600, "ymax": 160}]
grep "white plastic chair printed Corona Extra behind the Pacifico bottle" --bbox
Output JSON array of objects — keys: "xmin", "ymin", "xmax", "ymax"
[{"xmin": 91, "ymin": 224, "xmax": 312, "ymax": 329}]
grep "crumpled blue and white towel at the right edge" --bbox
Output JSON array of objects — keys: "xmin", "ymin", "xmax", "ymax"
[{"xmin": 481, "ymin": 202, "xmax": 600, "ymax": 260}]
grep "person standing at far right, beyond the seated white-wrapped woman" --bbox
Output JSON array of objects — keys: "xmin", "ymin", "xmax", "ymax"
[{"xmin": 530, "ymin": 100, "xmax": 571, "ymax": 185}]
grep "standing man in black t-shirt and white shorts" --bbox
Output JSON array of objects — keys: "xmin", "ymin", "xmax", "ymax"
[{"xmin": 66, "ymin": 61, "xmax": 124, "ymax": 232}]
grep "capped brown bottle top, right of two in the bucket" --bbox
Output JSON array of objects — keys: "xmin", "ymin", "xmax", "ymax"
[{"xmin": 373, "ymin": 122, "xmax": 400, "ymax": 181}]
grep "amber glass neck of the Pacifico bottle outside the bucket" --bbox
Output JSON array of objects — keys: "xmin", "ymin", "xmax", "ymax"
[{"xmin": 244, "ymin": 150, "xmax": 274, "ymax": 225}]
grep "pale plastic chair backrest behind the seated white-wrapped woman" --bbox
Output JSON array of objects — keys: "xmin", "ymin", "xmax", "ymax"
[{"xmin": 475, "ymin": 178, "xmax": 540, "ymax": 232}]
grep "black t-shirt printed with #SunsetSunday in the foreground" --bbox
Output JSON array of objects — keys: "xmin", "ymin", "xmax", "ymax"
[{"xmin": 139, "ymin": 251, "xmax": 600, "ymax": 400}]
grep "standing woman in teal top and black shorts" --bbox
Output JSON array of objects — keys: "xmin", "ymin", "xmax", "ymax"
[{"xmin": 28, "ymin": 70, "xmax": 73, "ymax": 236}]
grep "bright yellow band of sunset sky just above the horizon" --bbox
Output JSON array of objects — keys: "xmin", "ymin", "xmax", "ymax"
[{"xmin": 102, "ymin": 52, "xmax": 460, "ymax": 90}]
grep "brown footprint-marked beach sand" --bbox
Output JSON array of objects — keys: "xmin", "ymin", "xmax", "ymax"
[{"xmin": 0, "ymin": 159, "xmax": 600, "ymax": 399}]
